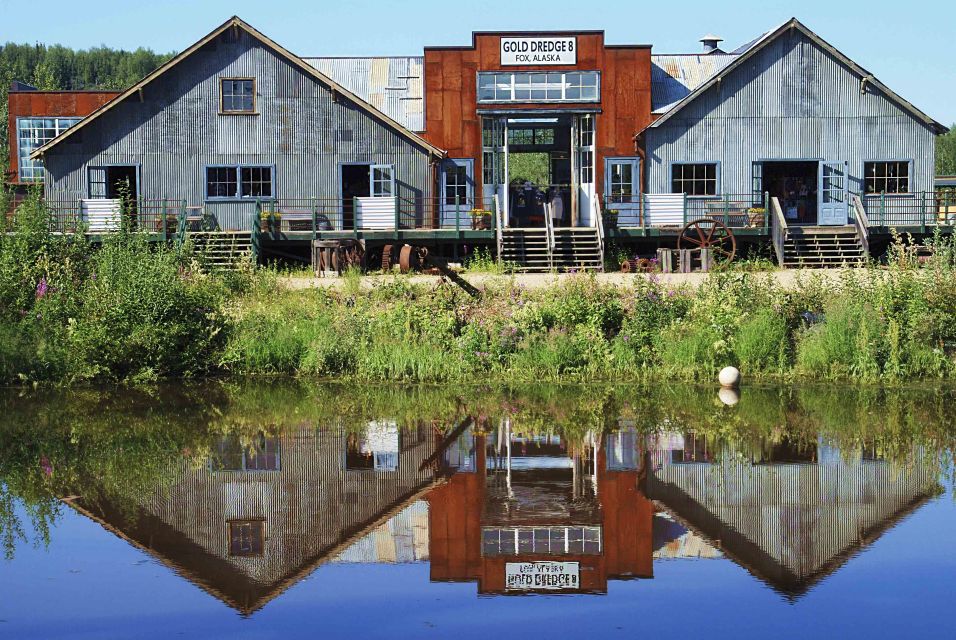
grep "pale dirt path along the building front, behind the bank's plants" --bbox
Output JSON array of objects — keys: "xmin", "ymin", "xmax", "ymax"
[{"xmin": 282, "ymin": 269, "xmax": 856, "ymax": 289}]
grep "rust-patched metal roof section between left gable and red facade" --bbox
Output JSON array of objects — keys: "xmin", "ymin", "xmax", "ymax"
[{"xmin": 303, "ymin": 56, "xmax": 425, "ymax": 131}]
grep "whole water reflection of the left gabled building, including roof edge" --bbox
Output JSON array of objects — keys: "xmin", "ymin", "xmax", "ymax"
[{"xmin": 72, "ymin": 423, "xmax": 434, "ymax": 614}]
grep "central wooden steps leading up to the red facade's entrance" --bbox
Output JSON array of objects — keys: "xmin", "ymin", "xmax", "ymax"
[{"xmin": 501, "ymin": 227, "xmax": 604, "ymax": 272}]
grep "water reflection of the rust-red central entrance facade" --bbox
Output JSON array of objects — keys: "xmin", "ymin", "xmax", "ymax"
[{"xmin": 428, "ymin": 424, "xmax": 653, "ymax": 593}]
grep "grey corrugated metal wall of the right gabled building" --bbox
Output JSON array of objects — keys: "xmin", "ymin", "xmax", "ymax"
[{"xmin": 645, "ymin": 30, "xmax": 935, "ymax": 194}]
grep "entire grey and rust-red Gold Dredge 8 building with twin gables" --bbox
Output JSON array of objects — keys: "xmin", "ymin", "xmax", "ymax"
[{"xmin": 20, "ymin": 18, "xmax": 953, "ymax": 269}]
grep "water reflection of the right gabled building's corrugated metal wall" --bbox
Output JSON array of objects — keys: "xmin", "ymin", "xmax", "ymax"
[{"xmin": 648, "ymin": 446, "xmax": 938, "ymax": 580}]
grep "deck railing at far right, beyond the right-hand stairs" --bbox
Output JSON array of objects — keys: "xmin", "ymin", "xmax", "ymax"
[{"xmin": 854, "ymin": 190, "xmax": 956, "ymax": 231}]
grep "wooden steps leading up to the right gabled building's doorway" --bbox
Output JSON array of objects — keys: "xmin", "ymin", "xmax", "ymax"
[{"xmin": 783, "ymin": 225, "xmax": 866, "ymax": 269}]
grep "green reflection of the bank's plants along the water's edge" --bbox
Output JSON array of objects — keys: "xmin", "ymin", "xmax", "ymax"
[{"xmin": 0, "ymin": 380, "xmax": 956, "ymax": 555}]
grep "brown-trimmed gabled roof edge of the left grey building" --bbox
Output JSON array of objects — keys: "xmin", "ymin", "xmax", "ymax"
[{"xmin": 30, "ymin": 16, "xmax": 445, "ymax": 159}]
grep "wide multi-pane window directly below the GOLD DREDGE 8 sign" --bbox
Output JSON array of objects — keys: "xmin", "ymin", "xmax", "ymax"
[{"xmin": 478, "ymin": 71, "xmax": 601, "ymax": 102}]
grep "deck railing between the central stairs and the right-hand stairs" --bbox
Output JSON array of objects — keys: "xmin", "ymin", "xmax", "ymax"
[{"xmin": 603, "ymin": 192, "xmax": 770, "ymax": 232}]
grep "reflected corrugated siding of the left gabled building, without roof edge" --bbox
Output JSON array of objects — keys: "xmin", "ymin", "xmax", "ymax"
[{"xmin": 143, "ymin": 428, "xmax": 434, "ymax": 585}]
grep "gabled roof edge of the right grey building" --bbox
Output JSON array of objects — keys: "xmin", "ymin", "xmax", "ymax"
[{"xmin": 644, "ymin": 18, "xmax": 949, "ymax": 134}]
